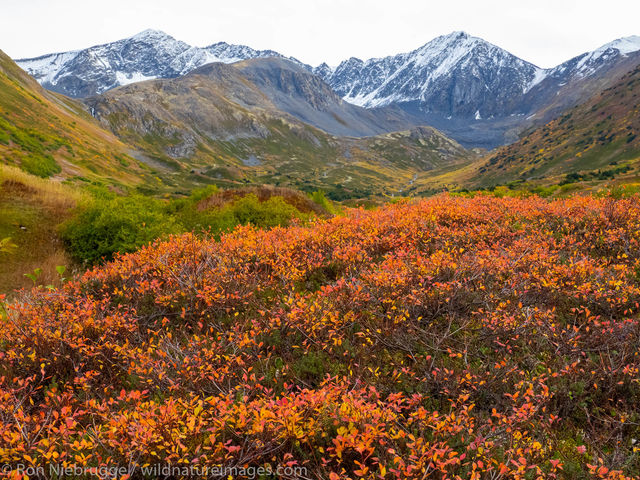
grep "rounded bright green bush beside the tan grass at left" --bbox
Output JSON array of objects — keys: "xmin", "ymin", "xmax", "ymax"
[{"xmin": 62, "ymin": 196, "xmax": 183, "ymax": 265}]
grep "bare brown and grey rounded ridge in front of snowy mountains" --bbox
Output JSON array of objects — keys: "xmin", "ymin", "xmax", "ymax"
[{"xmin": 85, "ymin": 59, "xmax": 469, "ymax": 195}]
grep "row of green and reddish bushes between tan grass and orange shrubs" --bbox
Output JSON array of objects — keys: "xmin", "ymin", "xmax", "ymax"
[{"xmin": 62, "ymin": 187, "xmax": 330, "ymax": 266}]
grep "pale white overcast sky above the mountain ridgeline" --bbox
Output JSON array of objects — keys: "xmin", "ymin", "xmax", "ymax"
[{"xmin": 0, "ymin": 0, "xmax": 640, "ymax": 67}]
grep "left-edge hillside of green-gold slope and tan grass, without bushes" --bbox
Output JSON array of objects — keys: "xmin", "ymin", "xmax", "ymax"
[{"xmin": 0, "ymin": 52, "xmax": 165, "ymax": 292}]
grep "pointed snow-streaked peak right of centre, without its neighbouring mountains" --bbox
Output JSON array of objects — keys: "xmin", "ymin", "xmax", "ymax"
[{"xmin": 316, "ymin": 32, "xmax": 539, "ymax": 117}]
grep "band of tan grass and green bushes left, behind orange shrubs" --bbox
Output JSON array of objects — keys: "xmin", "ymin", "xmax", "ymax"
[{"xmin": 0, "ymin": 165, "xmax": 336, "ymax": 293}]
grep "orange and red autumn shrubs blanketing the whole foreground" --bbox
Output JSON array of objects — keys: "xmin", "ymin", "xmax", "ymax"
[{"xmin": 0, "ymin": 195, "xmax": 640, "ymax": 480}]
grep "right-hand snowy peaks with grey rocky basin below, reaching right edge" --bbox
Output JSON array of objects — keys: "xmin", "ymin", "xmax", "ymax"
[{"xmin": 314, "ymin": 32, "xmax": 640, "ymax": 148}]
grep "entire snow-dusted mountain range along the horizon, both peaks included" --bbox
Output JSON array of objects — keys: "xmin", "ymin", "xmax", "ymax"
[{"xmin": 17, "ymin": 30, "xmax": 640, "ymax": 148}]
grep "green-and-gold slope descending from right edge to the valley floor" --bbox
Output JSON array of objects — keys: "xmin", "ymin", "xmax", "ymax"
[{"xmin": 412, "ymin": 67, "xmax": 640, "ymax": 194}]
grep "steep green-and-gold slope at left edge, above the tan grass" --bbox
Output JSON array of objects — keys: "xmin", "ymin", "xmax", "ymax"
[{"xmin": 0, "ymin": 47, "xmax": 151, "ymax": 185}]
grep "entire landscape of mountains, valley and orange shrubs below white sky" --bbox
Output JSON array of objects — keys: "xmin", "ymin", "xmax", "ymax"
[{"xmin": 0, "ymin": 22, "xmax": 640, "ymax": 480}]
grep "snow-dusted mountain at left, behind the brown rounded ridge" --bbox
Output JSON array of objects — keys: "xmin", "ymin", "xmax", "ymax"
[{"xmin": 16, "ymin": 30, "xmax": 300, "ymax": 98}]
